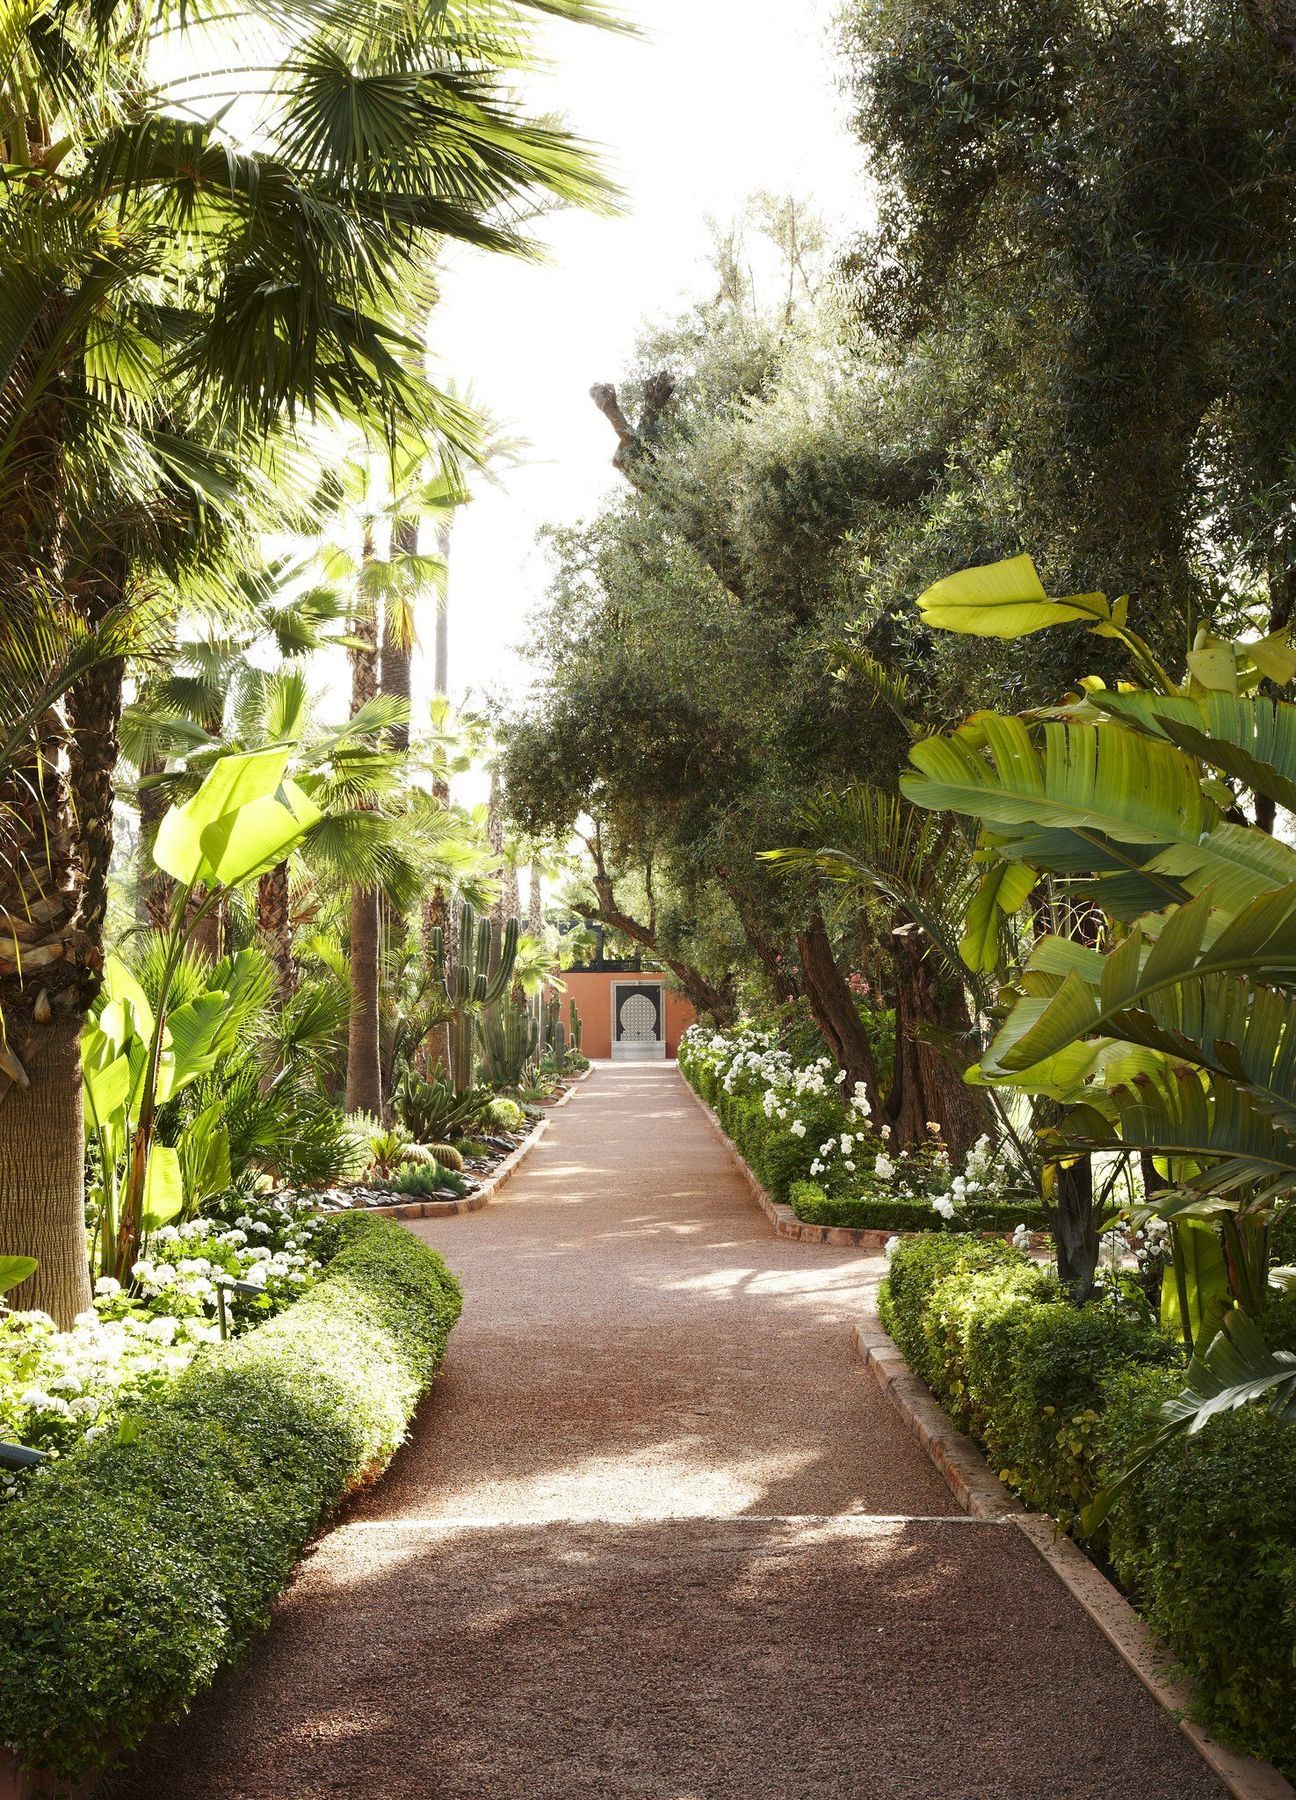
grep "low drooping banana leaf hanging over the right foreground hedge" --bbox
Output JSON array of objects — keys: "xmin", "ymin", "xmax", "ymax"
[{"xmin": 1082, "ymin": 1312, "xmax": 1296, "ymax": 1534}]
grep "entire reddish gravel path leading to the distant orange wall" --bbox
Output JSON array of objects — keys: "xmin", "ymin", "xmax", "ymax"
[{"xmin": 113, "ymin": 1064, "xmax": 1222, "ymax": 1800}]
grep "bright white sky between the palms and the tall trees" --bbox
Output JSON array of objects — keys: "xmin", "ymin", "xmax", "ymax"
[{"xmin": 416, "ymin": 0, "xmax": 866, "ymax": 718}]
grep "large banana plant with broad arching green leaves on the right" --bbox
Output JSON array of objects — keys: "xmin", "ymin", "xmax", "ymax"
[{"xmin": 900, "ymin": 556, "xmax": 1296, "ymax": 1350}]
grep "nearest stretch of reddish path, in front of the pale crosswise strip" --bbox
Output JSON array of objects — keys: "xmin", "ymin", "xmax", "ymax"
[{"xmin": 113, "ymin": 1519, "xmax": 1219, "ymax": 1800}]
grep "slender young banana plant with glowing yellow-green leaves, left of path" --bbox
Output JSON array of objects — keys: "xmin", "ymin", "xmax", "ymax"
[{"xmin": 81, "ymin": 745, "xmax": 319, "ymax": 1280}]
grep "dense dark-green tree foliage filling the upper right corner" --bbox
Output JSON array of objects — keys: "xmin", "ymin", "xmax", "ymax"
[{"xmin": 841, "ymin": 0, "xmax": 1296, "ymax": 648}]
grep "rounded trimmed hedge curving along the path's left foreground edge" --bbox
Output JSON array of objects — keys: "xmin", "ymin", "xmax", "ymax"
[{"xmin": 0, "ymin": 1215, "xmax": 461, "ymax": 1777}]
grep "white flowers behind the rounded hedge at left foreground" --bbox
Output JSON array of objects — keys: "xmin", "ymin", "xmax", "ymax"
[{"xmin": 0, "ymin": 1197, "xmax": 337, "ymax": 1499}]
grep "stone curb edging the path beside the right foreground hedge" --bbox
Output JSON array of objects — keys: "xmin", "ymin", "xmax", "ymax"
[{"xmin": 855, "ymin": 1319, "xmax": 1296, "ymax": 1800}]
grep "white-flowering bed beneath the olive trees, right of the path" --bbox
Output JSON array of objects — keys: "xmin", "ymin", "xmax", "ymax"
[{"xmin": 679, "ymin": 1026, "xmax": 1046, "ymax": 1231}]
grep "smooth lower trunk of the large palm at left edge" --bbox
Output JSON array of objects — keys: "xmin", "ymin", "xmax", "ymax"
[{"xmin": 0, "ymin": 1013, "xmax": 92, "ymax": 1330}]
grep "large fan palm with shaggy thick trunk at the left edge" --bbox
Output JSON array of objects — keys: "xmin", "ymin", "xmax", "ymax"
[{"xmin": 0, "ymin": 0, "xmax": 615, "ymax": 1321}]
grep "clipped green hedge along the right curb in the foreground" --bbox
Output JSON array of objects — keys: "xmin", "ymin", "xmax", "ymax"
[{"xmin": 880, "ymin": 1235, "xmax": 1296, "ymax": 1775}]
